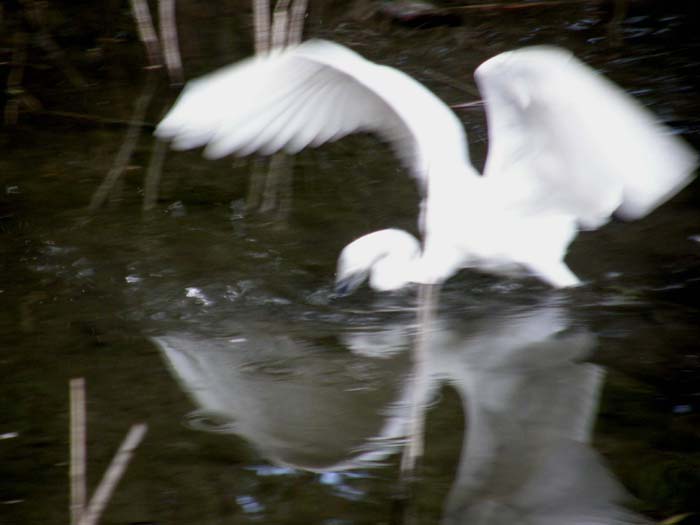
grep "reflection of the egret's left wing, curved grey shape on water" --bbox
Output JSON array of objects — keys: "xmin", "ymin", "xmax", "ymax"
[{"xmin": 154, "ymin": 322, "xmax": 410, "ymax": 472}]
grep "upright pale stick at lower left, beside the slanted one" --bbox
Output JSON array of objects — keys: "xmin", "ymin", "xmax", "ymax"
[{"xmin": 69, "ymin": 377, "xmax": 87, "ymax": 525}]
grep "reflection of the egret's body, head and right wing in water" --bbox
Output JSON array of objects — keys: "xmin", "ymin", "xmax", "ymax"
[{"xmin": 346, "ymin": 306, "xmax": 646, "ymax": 525}]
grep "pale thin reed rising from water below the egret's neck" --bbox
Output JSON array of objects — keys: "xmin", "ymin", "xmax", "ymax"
[{"xmin": 401, "ymin": 284, "xmax": 440, "ymax": 480}]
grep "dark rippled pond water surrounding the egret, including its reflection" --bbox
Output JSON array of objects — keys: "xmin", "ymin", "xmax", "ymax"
[{"xmin": 0, "ymin": 2, "xmax": 700, "ymax": 525}]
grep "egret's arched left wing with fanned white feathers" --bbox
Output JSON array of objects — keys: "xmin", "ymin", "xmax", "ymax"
[{"xmin": 156, "ymin": 40, "xmax": 468, "ymax": 190}]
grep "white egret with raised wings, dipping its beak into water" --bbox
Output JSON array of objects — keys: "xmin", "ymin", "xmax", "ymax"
[{"xmin": 156, "ymin": 41, "xmax": 696, "ymax": 291}]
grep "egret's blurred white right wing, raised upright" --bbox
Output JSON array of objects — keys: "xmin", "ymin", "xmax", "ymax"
[{"xmin": 475, "ymin": 47, "xmax": 697, "ymax": 227}]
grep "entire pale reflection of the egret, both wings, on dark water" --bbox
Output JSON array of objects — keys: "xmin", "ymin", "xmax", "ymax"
[{"xmin": 150, "ymin": 305, "xmax": 643, "ymax": 525}]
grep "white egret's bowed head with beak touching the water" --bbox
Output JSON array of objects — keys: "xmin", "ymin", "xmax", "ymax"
[{"xmin": 335, "ymin": 228, "xmax": 420, "ymax": 295}]
